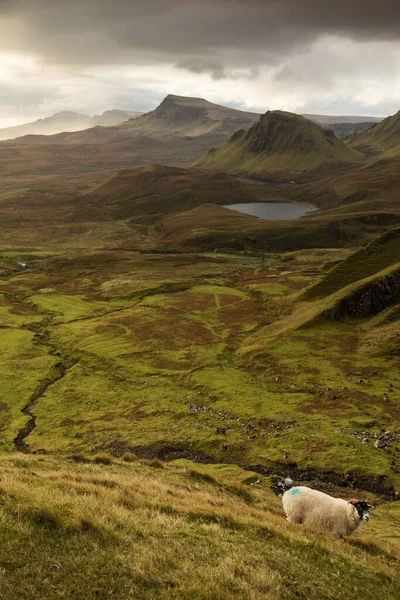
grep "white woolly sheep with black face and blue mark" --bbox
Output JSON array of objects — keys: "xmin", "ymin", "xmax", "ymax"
[{"xmin": 282, "ymin": 486, "xmax": 373, "ymax": 538}]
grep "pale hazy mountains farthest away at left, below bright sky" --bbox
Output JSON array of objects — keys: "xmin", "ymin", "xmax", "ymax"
[{"xmin": 0, "ymin": 109, "xmax": 143, "ymax": 140}]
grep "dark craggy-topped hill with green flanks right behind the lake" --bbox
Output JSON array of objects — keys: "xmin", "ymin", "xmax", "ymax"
[{"xmin": 195, "ymin": 111, "xmax": 362, "ymax": 179}]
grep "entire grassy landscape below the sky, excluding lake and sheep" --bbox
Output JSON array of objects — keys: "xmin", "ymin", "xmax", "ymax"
[{"xmin": 0, "ymin": 91, "xmax": 400, "ymax": 600}]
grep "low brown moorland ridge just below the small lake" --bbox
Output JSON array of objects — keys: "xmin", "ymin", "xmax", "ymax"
[{"xmin": 152, "ymin": 204, "xmax": 400, "ymax": 252}]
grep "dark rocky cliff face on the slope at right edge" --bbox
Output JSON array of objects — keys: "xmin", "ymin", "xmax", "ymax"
[{"xmin": 323, "ymin": 269, "xmax": 400, "ymax": 321}]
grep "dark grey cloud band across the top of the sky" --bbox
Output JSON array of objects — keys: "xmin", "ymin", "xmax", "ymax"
[{"xmin": 0, "ymin": 0, "xmax": 400, "ymax": 72}]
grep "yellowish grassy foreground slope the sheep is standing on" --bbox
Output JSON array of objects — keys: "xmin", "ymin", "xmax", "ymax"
[{"xmin": 0, "ymin": 455, "xmax": 400, "ymax": 600}]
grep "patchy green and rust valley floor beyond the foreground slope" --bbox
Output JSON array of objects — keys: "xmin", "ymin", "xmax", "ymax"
[{"xmin": 2, "ymin": 250, "xmax": 399, "ymax": 489}]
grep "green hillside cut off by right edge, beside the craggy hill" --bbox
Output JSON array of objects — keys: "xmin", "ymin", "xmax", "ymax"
[{"xmin": 351, "ymin": 111, "xmax": 400, "ymax": 157}]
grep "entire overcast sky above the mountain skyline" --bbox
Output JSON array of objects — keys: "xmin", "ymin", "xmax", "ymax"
[{"xmin": 0, "ymin": 0, "xmax": 400, "ymax": 126}]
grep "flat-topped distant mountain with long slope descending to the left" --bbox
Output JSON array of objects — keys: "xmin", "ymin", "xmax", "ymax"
[{"xmin": 0, "ymin": 96, "xmax": 259, "ymax": 177}]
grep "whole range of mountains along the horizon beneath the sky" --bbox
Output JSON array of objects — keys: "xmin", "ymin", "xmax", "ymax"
[{"xmin": 0, "ymin": 95, "xmax": 400, "ymax": 197}]
